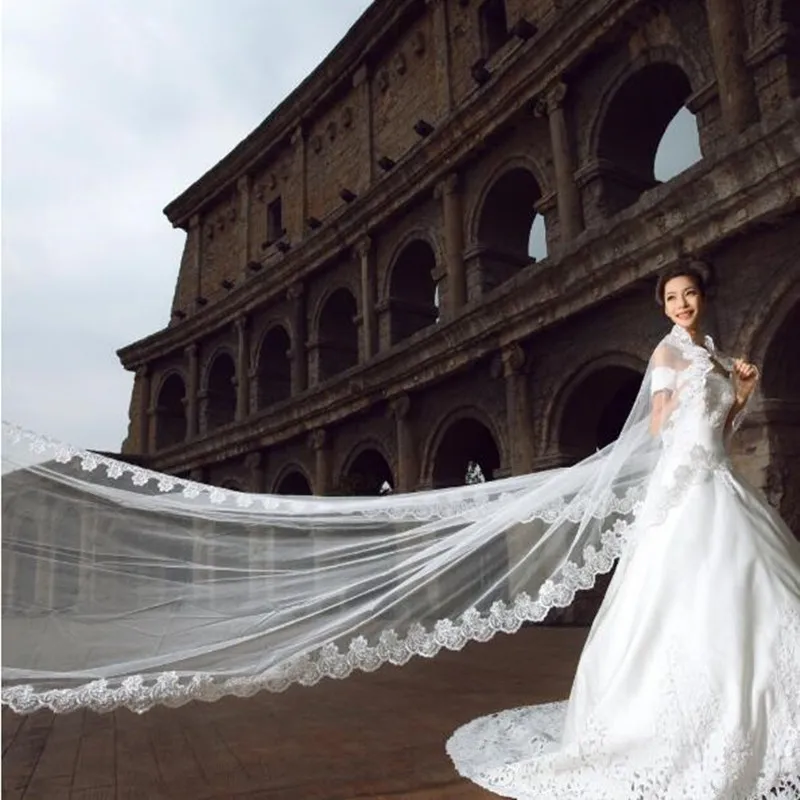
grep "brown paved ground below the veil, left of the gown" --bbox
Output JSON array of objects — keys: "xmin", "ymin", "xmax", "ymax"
[{"xmin": 2, "ymin": 628, "xmax": 586, "ymax": 800}]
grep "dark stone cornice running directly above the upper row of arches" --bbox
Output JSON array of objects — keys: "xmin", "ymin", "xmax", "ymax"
[{"xmin": 118, "ymin": 0, "xmax": 641, "ymax": 370}]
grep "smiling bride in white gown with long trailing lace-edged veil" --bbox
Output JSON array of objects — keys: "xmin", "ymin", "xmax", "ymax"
[{"xmin": 2, "ymin": 266, "xmax": 800, "ymax": 800}]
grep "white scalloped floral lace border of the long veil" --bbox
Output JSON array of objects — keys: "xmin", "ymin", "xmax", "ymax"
[{"xmin": 2, "ymin": 324, "xmax": 780, "ymax": 713}]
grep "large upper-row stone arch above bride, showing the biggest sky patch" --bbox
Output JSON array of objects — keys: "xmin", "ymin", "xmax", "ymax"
[{"xmin": 588, "ymin": 46, "xmax": 703, "ymax": 214}]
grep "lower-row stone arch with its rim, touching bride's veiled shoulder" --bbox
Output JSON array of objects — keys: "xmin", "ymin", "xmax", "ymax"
[{"xmin": 548, "ymin": 353, "xmax": 647, "ymax": 461}]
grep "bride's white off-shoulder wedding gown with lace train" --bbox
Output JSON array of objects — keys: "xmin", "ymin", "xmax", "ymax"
[{"xmin": 447, "ymin": 327, "xmax": 800, "ymax": 800}]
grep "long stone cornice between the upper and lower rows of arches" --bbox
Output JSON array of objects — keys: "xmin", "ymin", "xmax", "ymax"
[{"xmin": 144, "ymin": 122, "xmax": 800, "ymax": 472}]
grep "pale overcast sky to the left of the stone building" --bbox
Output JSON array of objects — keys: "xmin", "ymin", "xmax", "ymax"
[{"xmin": 2, "ymin": 0, "xmax": 695, "ymax": 450}]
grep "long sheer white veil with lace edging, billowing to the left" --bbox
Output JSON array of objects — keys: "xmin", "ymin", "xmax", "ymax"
[{"xmin": 2, "ymin": 340, "xmax": 744, "ymax": 713}]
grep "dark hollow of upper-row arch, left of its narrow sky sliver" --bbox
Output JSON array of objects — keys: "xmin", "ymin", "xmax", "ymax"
[{"xmin": 474, "ymin": 167, "xmax": 547, "ymax": 292}]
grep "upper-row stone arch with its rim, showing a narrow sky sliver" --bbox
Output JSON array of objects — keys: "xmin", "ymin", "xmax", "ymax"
[{"xmin": 468, "ymin": 156, "xmax": 546, "ymax": 292}]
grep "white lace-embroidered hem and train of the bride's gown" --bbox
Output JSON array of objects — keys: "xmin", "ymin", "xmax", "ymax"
[{"xmin": 447, "ymin": 576, "xmax": 800, "ymax": 800}]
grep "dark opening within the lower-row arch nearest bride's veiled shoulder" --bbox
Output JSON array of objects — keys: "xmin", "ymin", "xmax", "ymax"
[{"xmin": 559, "ymin": 365, "xmax": 643, "ymax": 461}]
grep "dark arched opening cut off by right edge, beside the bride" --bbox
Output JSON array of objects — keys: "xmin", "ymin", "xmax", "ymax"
[{"xmin": 761, "ymin": 302, "xmax": 800, "ymax": 539}]
